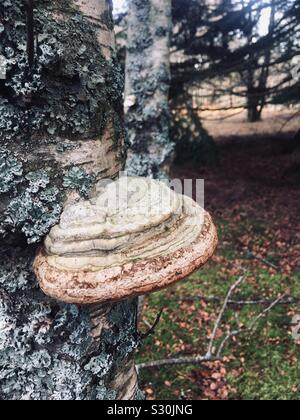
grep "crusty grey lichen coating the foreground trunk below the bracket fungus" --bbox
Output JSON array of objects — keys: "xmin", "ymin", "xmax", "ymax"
[{"xmin": 0, "ymin": 241, "xmax": 136, "ymax": 400}]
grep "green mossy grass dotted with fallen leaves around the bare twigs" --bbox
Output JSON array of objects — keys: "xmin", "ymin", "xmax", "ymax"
[{"xmin": 137, "ymin": 218, "xmax": 300, "ymax": 400}]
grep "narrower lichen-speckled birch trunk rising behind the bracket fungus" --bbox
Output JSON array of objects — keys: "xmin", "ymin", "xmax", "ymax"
[{"xmin": 125, "ymin": 0, "xmax": 173, "ymax": 177}]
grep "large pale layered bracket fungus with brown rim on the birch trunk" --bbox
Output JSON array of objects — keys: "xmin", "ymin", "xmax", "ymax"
[{"xmin": 34, "ymin": 177, "xmax": 218, "ymax": 305}]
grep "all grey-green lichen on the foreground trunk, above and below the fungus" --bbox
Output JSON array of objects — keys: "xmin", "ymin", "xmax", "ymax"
[{"xmin": 0, "ymin": 0, "xmax": 138, "ymax": 400}]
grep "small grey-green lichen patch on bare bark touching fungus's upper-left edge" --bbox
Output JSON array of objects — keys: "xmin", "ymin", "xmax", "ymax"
[{"xmin": 63, "ymin": 166, "xmax": 95, "ymax": 197}]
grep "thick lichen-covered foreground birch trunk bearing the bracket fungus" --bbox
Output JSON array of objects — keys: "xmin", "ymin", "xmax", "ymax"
[{"xmin": 0, "ymin": 0, "xmax": 139, "ymax": 400}]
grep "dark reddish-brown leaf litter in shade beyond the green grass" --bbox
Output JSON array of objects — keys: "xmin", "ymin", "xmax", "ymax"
[{"xmin": 172, "ymin": 133, "xmax": 300, "ymax": 275}]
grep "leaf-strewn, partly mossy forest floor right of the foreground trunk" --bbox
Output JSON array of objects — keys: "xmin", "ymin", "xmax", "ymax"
[{"xmin": 138, "ymin": 128, "xmax": 300, "ymax": 400}]
